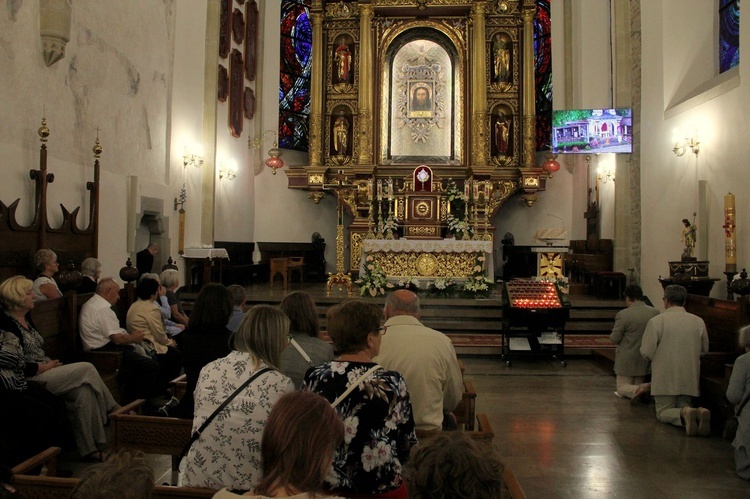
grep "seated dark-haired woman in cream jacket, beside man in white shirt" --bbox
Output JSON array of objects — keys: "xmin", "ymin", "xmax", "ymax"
[{"xmin": 125, "ymin": 278, "xmax": 182, "ymax": 390}]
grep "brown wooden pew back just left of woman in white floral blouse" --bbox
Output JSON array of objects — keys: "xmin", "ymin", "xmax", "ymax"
[{"xmin": 109, "ymin": 399, "xmax": 193, "ymax": 485}]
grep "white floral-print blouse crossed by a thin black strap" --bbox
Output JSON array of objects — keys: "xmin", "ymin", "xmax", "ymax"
[{"xmin": 182, "ymin": 350, "xmax": 294, "ymax": 490}]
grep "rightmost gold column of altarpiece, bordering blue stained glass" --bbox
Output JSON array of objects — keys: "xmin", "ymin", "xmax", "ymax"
[{"xmin": 521, "ymin": 4, "xmax": 536, "ymax": 168}]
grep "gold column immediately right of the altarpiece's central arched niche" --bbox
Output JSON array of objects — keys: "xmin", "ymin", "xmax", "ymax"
[{"xmin": 470, "ymin": 2, "xmax": 490, "ymax": 165}]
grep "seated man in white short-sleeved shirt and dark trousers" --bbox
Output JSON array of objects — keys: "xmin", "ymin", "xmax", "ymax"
[{"xmin": 79, "ymin": 277, "xmax": 159, "ymax": 400}]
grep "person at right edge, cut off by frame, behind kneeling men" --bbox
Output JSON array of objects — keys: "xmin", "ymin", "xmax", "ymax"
[{"xmin": 727, "ymin": 326, "xmax": 750, "ymax": 480}]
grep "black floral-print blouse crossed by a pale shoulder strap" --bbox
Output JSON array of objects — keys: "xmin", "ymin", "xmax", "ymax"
[{"xmin": 302, "ymin": 361, "xmax": 417, "ymax": 496}]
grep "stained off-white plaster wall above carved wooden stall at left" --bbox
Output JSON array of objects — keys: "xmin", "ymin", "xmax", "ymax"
[{"xmin": 0, "ymin": 0, "xmax": 174, "ymax": 282}]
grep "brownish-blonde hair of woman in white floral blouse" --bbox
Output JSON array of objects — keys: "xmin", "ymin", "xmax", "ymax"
[{"xmin": 234, "ymin": 305, "xmax": 289, "ymax": 369}]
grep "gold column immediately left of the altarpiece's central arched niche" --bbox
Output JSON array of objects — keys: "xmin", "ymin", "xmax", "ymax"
[{"xmin": 356, "ymin": 4, "xmax": 374, "ymax": 165}]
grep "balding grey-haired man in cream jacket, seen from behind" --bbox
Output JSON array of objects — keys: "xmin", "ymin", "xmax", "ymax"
[{"xmin": 374, "ymin": 289, "xmax": 463, "ymax": 430}]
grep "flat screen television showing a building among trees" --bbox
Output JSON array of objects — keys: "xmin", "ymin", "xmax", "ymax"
[{"xmin": 552, "ymin": 107, "xmax": 633, "ymax": 154}]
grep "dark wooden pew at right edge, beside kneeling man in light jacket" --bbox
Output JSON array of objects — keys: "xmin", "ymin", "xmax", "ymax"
[{"xmin": 685, "ymin": 294, "xmax": 750, "ymax": 431}]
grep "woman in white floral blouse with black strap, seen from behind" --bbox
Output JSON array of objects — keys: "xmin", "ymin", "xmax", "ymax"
[{"xmin": 183, "ymin": 305, "xmax": 294, "ymax": 490}]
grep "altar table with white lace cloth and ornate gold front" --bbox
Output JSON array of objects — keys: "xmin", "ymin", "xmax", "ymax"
[{"xmin": 360, "ymin": 239, "xmax": 495, "ymax": 280}]
